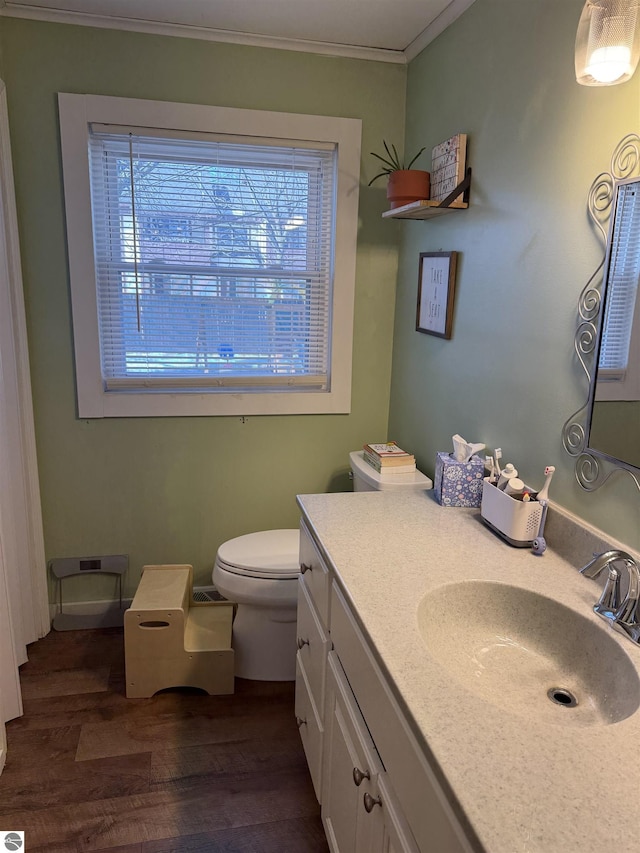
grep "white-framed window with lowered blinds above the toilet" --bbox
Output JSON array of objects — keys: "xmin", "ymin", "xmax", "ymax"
[{"xmin": 59, "ymin": 94, "xmax": 360, "ymax": 417}]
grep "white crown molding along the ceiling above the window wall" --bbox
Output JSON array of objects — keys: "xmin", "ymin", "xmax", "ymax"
[{"xmin": 0, "ymin": 0, "xmax": 410, "ymax": 65}]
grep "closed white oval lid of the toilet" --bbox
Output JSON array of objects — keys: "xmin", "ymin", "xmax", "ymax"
[{"xmin": 218, "ymin": 530, "xmax": 300, "ymax": 578}]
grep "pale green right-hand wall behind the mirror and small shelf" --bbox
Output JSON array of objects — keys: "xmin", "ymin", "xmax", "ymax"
[{"xmin": 389, "ymin": 0, "xmax": 640, "ymax": 548}]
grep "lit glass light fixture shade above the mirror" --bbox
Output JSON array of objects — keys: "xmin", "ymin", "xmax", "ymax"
[{"xmin": 576, "ymin": 0, "xmax": 640, "ymax": 86}]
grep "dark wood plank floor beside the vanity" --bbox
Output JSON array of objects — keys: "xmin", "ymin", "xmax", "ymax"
[{"xmin": 0, "ymin": 629, "xmax": 328, "ymax": 853}]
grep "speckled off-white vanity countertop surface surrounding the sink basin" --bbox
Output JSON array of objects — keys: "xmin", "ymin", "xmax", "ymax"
[{"xmin": 298, "ymin": 492, "xmax": 640, "ymax": 853}]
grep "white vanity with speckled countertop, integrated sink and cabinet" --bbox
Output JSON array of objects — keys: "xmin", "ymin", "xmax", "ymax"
[{"xmin": 296, "ymin": 492, "xmax": 640, "ymax": 853}]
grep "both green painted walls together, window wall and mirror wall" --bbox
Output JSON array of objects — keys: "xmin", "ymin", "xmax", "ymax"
[{"xmin": 5, "ymin": 0, "xmax": 640, "ymax": 599}]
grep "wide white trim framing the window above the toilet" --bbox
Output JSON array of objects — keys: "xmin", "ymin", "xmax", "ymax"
[{"xmin": 58, "ymin": 93, "xmax": 362, "ymax": 418}]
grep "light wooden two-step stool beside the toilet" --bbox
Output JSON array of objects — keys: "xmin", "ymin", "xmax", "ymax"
[{"xmin": 124, "ymin": 566, "xmax": 234, "ymax": 699}]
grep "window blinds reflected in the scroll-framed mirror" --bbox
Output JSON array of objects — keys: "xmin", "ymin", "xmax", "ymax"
[{"xmin": 598, "ymin": 181, "xmax": 640, "ymax": 380}]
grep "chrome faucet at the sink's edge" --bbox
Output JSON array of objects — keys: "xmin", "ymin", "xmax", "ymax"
[{"xmin": 580, "ymin": 550, "xmax": 640, "ymax": 643}]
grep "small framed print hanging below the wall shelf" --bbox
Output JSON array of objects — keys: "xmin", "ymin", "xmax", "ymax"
[{"xmin": 416, "ymin": 252, "xmax": 458, "ymax": 339}]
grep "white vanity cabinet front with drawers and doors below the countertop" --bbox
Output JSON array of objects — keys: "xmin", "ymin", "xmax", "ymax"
[{"xmin": 296, "ymin": 522, "xmax": 472, "ymax": 853}]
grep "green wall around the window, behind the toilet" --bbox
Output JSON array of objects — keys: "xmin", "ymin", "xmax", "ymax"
[{"xmin": 0, "ymin": 18, "xmax": 406, "ymax": 599}]
